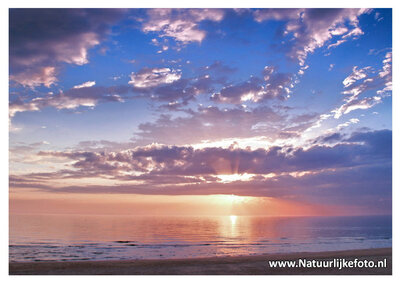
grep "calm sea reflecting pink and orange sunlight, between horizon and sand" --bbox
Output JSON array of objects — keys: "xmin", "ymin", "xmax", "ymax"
[{"xmin": 9, "ymin": 214, "xmax": 392, "ymax": 262}]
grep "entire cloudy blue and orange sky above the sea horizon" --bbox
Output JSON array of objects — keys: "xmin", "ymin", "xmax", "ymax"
[{"xmin": 9, "ymin": 8, "xmax": 392, "ymax": 215}]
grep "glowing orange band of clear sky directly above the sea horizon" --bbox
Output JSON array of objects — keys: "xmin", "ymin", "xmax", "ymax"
[{"xmin": 9, "ymin": 191, "xmax": 372, "ymax": 216}]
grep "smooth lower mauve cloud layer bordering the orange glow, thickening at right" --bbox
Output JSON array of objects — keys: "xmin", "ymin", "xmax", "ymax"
[{"xmin": 10, "ymin": 162, "xmax": 392, "ymax": 214}]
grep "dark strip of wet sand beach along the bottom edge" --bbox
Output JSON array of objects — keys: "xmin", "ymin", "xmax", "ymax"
[{"xmin": 9, "ymin": 248, "xmax": 392, "ymax": 275}]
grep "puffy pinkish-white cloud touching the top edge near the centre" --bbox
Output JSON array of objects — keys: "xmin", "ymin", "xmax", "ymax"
[{"xmin": 142, "ymin": 9, "xmax": 224, "ymax": 44}]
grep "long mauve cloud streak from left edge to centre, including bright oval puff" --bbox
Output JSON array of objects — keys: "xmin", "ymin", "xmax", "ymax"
[{"xmin": 9, "ymin": 68, "xmax": 224, "ymax": 117}]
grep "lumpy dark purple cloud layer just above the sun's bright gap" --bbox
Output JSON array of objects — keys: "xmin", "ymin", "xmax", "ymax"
[{"xmin": 29, "ymin": 130, "xmax": 392, "ymax": 181}]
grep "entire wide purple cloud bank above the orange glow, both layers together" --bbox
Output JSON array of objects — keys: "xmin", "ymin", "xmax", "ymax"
[{"xmin": 10, "ymin": 130, "xmax": 392, "ymax": 212}]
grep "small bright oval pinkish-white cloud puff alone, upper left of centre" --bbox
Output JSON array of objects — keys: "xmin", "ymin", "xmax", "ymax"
[{"xmin": 129, "ymin": 68, "xmax": 182, "ymax": 88}]
